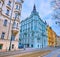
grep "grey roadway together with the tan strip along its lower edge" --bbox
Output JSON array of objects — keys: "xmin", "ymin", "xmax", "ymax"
[{"xmin": 0, "ymin": 47, "xmax": 57, "ymax": 57}]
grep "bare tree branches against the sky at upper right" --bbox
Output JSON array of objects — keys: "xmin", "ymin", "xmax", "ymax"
[{"xmin": 51, "ymin": 0, "xmax": 60, "ymax": 24}]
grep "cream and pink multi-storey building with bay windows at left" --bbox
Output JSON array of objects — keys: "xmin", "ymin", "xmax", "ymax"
[{"xmin": 0, "ymin": 0, "xmax": 23, "ymax": 51}]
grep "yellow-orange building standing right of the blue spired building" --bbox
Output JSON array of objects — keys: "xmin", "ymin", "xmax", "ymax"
[{"xmin": 47, "ymin": 26, "xmax": 56, "ymax": 47}]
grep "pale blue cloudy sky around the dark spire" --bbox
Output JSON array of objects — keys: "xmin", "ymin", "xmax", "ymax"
[{"xmin": 21, "ymin": 0, "xmax": 60, "ymax": 36}]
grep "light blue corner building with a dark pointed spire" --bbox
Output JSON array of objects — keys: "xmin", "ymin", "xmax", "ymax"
[{"xmin": 19, "ymin": 5, "xmax": 47, "ymax": 48}]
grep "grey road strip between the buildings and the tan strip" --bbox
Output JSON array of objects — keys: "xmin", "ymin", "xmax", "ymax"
[{"xmin": 0, "ymin": 47, "xmax": 56, "ymax": 57}]
